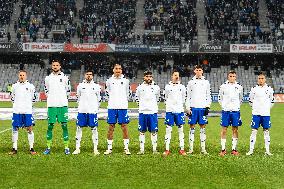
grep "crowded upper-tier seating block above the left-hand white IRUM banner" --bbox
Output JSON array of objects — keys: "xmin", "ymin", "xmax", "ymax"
[{"xmin": 17, "ymin": 0, "xmax": 76, "ymax": 42}]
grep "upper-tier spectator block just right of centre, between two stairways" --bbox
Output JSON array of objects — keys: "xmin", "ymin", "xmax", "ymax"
[{"xmin": 142, "ymin": 0, "xmax": 197, "ymax": 45}]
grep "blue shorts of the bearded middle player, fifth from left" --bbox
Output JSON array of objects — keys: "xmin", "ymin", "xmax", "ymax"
[{"xmin": 138, "ymin": 113, "xmax": 158, "ymax": 132}]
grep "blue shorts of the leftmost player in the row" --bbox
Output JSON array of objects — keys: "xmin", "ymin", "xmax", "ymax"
[{"xmin": 12, "ymin": 113, "xmax": 34, "ymax": 130}]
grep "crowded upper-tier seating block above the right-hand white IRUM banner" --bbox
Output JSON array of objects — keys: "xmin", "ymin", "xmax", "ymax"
[{"xmin": 204, "ymin": 0, "xmax": 272, "ymax": 44}]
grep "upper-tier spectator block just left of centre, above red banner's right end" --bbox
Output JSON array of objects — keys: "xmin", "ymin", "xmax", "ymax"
[{"xmin": 77, "ymin": 0, "xmax": 136, "ymax": 44}]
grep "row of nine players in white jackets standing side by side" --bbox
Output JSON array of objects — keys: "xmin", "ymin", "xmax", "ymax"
[{"xmin": 9, "ymin": 60, "xmax": 274, "ymax": 156}]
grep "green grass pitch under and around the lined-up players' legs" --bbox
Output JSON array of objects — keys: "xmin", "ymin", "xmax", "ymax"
[{"xmin": 0, "ymin": 102, "xmax": 284, "ymax": 189}]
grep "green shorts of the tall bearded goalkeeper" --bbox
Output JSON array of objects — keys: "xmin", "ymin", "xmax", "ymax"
[{"xmin": 47, "ymin": 106, "xmax": 68, "ymax": 123}]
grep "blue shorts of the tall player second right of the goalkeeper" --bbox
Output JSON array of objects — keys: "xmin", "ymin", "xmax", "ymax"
[{"xmin": 107, "ymin": 109, "xmax": 130, "ymax": 124}]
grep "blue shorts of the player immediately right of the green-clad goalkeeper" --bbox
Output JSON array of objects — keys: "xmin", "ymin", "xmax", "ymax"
[{"xmin": 77, "ymin": 113, "xmax": 99, "ymax": 127}]
